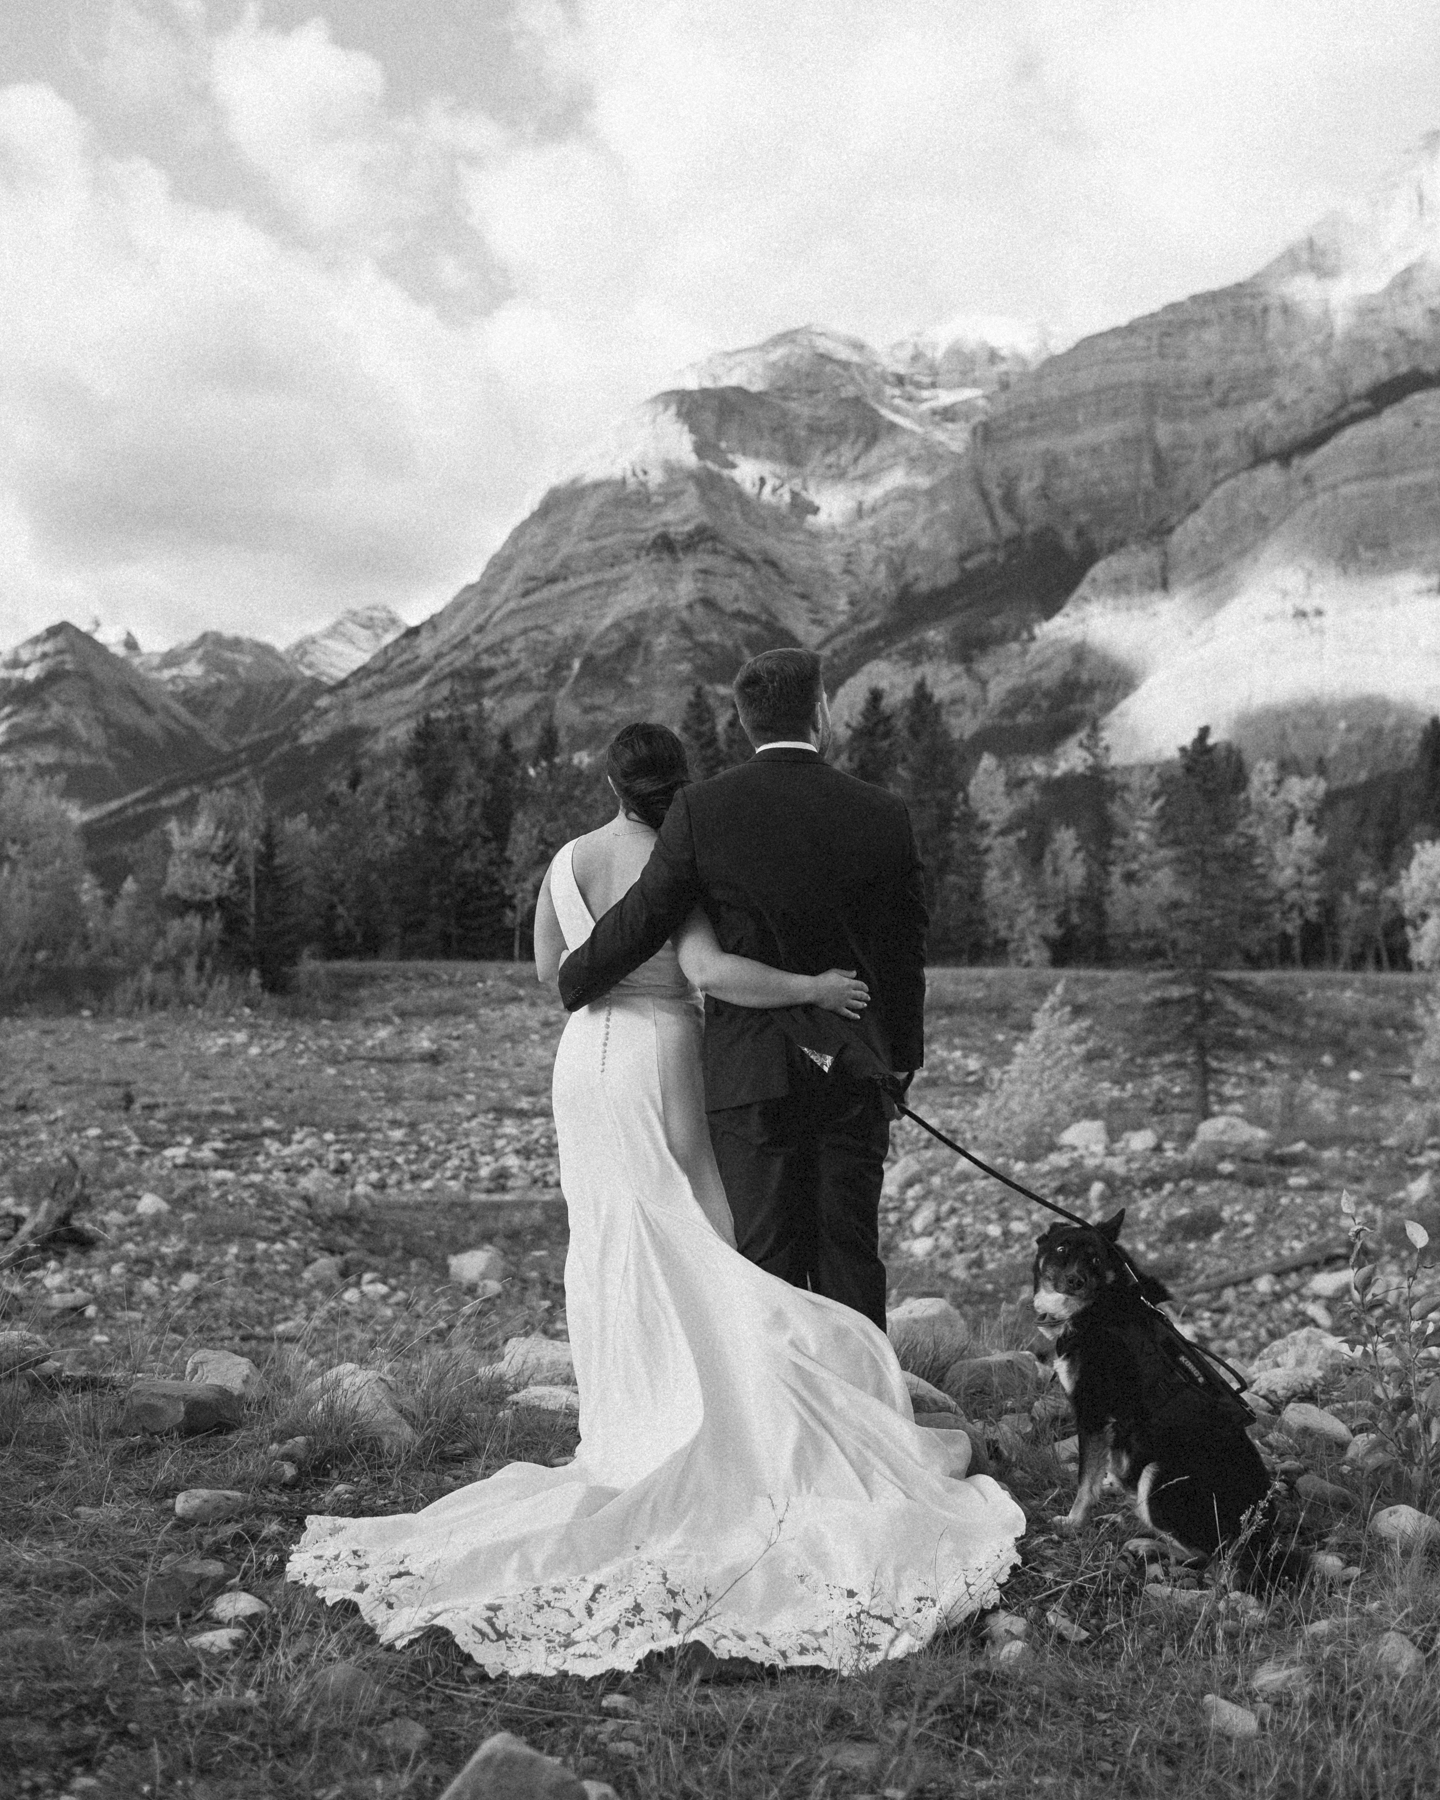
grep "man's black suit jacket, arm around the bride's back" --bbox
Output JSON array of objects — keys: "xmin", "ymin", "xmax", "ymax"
[{"xmin": 560, "ymin": 749, "xmax": 929, "ymax": 1112}]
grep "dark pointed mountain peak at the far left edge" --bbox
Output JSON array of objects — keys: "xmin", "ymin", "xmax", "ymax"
[{"xmin": 0, "ymin": 623, "xmax": 225, "ymax": 806}]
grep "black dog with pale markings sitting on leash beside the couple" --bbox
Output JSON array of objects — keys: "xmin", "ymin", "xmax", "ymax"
[{"xmin": 1033, "ymin": 1210, "xmax": 1307, "ymax": 1575}]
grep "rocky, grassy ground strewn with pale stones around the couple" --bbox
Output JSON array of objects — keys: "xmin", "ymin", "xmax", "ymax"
[{"xmin": 0, "ymin": 965, "xmax": 1440, "ymax": 1800}]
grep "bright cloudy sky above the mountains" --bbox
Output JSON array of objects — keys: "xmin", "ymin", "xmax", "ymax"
[{"xmin": 0, "ymin": 0, "xmax": 1440, "ymax": 648}]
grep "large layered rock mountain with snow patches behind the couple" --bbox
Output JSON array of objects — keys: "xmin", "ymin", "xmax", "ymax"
[{"xmin": 2, "ymin": 133, "xmax": 1440, "ymax": 831}]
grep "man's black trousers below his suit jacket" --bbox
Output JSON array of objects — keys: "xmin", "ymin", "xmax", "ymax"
[{"xmin": 709, "ymin": 1046, "xmax": 889, "ymax": 1330}]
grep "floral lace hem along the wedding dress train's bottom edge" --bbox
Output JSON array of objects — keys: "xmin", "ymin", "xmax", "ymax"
[{"xmin": 286, "ymin": 1517, "xmax": 1021, "ymax": 1676}]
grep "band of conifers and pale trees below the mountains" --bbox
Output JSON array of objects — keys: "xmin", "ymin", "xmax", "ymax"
[{"xmin": 0, "ymin": 680, "xmax": 1440, "ymax": 999}]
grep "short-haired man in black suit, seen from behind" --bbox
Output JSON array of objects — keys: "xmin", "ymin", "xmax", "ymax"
[{"xmin": 560, "ymin": 650, "xmax": 929, "ymax": 1330}]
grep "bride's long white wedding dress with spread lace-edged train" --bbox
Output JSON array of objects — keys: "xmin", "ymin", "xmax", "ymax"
[{"xmin": 288, "ymin": 844, "xmax": 1024, "ymax": 1676}]
